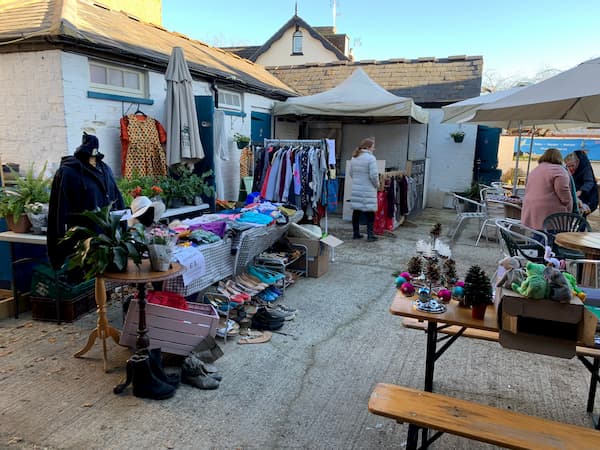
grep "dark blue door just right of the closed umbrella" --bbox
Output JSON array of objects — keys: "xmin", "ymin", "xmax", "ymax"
[{"xmin": 194, "ymin": 95, "xmax": 215, "ymax": 211}]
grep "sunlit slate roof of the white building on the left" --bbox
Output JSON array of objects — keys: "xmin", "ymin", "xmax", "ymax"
[{"xmin": 0, "ymin": 0, "xmax": 295, "ymax": 99}]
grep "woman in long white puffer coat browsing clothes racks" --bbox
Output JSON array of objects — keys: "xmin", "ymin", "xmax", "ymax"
[{"xmin": 350, "ymin": 138, "xmax": 379, "ymax": 242}]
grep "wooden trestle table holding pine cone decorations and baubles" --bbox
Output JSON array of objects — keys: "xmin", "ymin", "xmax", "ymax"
[{"xmin": 390, "ymin": 292, "xmax": 600, "ymax": 428}]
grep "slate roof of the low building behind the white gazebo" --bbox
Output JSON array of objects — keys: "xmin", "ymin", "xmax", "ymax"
[{"xmin": 267, "ymin": 55, "xmax": 483, "ymax": 108}]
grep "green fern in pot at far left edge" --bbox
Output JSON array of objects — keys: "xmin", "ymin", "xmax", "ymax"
[{"xmin": 0, "ymin": 164, "xmax": 52, "ymax": 233}]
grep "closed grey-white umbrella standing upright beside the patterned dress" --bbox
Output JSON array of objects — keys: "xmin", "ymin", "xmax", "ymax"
[{"xmin": 165, "ymin": 47, "xmax": 204, "ymax": 166}]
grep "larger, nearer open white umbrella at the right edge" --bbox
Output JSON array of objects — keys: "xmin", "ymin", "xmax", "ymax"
[{"xmin": 470, "ymin": 58, "xmax": 600, "ymax": 128}]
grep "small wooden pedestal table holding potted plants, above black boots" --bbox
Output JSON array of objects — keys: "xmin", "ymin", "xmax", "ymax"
[{"xmin": 74, "ymin": 260, "xmax": 184, "ymax": 372}]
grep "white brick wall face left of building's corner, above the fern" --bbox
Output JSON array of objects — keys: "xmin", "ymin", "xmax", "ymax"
[{"xmin": 0, "ymin": 50, "xmax": 66, "ymax": 171}]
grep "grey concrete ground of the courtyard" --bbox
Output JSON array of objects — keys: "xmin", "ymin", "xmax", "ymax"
[{"xmin": 0, "ymin": 210, "xmax": 598, "ymax": 449}]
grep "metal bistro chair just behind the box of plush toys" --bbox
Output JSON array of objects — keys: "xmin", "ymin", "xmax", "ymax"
[{"xmin": 496, "ymin": 219, "xmax": 548, "ymax": 264}]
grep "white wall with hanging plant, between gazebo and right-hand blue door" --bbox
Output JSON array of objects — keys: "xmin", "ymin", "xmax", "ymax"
[{"xmin": 427, "ymin": 109, "xmax": 477, "ymax": 208}]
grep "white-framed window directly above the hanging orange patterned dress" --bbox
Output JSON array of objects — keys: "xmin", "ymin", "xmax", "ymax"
[{"xmin": 90, "ymin": 61, "xmax": 147, "ymax": 98}]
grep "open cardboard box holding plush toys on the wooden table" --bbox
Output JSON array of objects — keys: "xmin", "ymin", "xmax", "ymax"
[{"xmin": 497, "ymin": 288, "xmax": 584, "ymax": 358}]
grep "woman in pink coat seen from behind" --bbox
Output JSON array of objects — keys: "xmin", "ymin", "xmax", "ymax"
[{"xmin": 521, "ymin": 148, "xmax": 573, "ymax": 230}]
